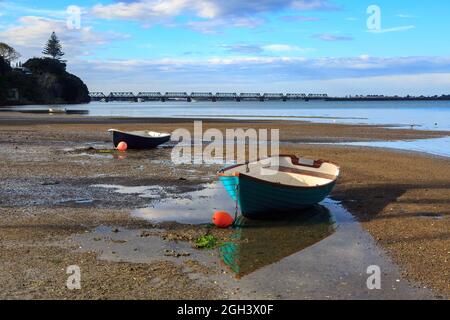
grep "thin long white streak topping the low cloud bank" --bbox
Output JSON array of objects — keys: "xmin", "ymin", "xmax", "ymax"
[{"xmin": 75, "ymin": 55, "xmax": 450, "ymax": 79}]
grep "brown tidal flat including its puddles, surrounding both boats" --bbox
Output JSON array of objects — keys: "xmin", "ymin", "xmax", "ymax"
[{"xmin": 0, "ymin": 112, "xmax": 450, "ymax": 299}]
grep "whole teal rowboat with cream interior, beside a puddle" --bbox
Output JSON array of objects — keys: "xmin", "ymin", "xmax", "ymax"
[{"xmin": 218, "ymin": 155, "xmax": 339, "ymax": 219}]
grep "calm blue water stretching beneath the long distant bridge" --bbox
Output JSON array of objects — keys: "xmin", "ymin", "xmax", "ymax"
[{"xmin": 7, "ymin": 101, "xmax": 450, "ymax": 131}]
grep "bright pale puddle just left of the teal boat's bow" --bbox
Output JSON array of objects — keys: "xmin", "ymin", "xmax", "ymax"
[{"xmin": 133, "ymin": 183, "xmax": 234, "ymax": 224}]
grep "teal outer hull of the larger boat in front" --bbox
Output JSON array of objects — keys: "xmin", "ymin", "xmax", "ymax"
[{"xmin": 220, "ymin": 174, "xmax": 336, "ymax": 219}]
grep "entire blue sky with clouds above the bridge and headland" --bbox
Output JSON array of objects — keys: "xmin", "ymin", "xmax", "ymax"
[{"xmin": 0, "ymin": 0, "xmax": 450, "ymax": 95}]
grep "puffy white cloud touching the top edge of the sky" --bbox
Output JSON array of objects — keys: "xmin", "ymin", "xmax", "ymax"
[{"xmin": 91, "ymin": 0, "xmax": 337, "ymax": 33}]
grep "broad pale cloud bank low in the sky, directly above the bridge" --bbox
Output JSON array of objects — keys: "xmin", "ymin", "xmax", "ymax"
[{"xmin": 71, "ymin": 57, "xmax": 450, "ymax": 95}]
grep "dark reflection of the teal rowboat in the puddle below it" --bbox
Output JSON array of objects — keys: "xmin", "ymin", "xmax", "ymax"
[{"xmin": 219, "ymin": 205, "xmax": 335, "ymax": 278}]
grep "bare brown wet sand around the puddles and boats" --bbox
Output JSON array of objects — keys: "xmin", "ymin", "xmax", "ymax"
[{"xmin": 0, "ymin": 113, "xmax": 450, "ymax": 299}]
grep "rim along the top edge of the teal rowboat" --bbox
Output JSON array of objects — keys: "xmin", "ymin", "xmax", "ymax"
[{"xmin": 217, "ymin": 155, "xmax": 340, "ymax": 189}]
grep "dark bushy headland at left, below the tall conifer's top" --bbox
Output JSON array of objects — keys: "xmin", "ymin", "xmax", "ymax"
[{"xmin": 0, "ymin": 57, "xmax": 90, "ymax": 105}]
